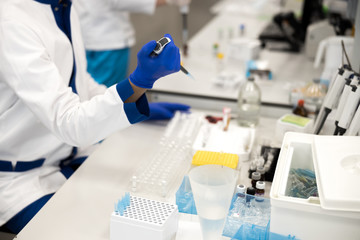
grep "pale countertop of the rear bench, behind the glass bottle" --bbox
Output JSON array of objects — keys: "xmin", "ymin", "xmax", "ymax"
[{"xmin": 151, "ymin": 14, "xmax": 321, "ymax": 107}]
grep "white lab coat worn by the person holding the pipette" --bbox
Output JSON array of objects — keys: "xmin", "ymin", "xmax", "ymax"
[{"xmin": 0, "ymin": 0, "xmax": 146, "ymax": 226}]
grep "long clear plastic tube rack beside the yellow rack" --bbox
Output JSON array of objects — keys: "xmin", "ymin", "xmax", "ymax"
[{"xmin": 130, "ymin": 112, "xmax": 205, "ymax": 198}]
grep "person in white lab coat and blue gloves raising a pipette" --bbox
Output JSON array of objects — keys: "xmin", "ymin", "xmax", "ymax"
[{"xmin": 0, "ymin": 0, "xmax": 180, "ymax": 233}]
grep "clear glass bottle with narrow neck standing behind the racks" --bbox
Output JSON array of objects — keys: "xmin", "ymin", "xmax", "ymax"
[{"xmin": 237, "ymin": 77, "xmax": 261, "ymax": 127}]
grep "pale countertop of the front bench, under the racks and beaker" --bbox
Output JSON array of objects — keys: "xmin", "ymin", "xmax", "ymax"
[{"xmin": 16, "ymin": 115, "xmax": 276, "ymax": 240}]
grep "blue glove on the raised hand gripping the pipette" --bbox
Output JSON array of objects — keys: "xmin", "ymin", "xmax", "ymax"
[{"xmin": 130, "ymin": 34, "xmax": 180, "ymax": 88}]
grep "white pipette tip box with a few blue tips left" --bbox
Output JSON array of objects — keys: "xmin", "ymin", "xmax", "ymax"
[{"xmin": 110, "ymin": 195, "xmax": 179, "ymax": 240}]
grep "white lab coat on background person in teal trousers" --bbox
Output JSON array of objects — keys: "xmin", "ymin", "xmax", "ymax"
[{"xmin": 73, "ymin": 0, "xmax": 156, "ymax": 51}]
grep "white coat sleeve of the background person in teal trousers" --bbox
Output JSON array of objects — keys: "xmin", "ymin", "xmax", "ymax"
[{"xmin": 107, "ymin": 0, "xmax": 156, "ymax": 14}]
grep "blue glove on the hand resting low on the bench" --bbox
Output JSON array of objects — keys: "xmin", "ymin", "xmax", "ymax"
[{"xmin": 148, "ymin": 102, "xmax": 190, "ymax": 120}]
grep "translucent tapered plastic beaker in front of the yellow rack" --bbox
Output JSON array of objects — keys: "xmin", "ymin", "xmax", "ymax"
[{"xmin": 189, "ymin": 165, "xmax": 237, "ymax": 240}]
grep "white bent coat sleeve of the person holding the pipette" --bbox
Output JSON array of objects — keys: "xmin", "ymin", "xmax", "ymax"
[{"xmin": 0, "ymin": 21, "xmax": 148, "ymax": 147}]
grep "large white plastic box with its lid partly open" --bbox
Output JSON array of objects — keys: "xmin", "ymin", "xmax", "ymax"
[{"xmin": 270, "ymin": 132, "xmax": 360, "ymax": 240}]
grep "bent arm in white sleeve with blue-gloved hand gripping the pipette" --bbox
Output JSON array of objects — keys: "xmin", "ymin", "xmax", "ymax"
[{"xmin": 0, "ymin": 19, "xmax": 180, "ymax": 146}]
